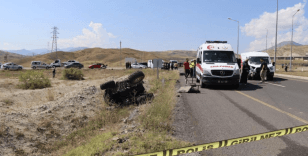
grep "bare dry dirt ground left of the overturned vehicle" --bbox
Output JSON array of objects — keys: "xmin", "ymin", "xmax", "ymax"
[{"xmin": 0, "ymin": 69, "xmax": 152, "ymax": 155}]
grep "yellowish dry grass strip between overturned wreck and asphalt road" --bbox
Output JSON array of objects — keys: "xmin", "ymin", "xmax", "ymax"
[{"xmin": 53, "ymin": 69, "xmax": 191, "ymax": 156}]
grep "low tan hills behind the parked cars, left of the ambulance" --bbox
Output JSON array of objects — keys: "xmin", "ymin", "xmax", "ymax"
[{"xmin": 10, "ymin": 48, "xmax": 196, "ymax": 67}]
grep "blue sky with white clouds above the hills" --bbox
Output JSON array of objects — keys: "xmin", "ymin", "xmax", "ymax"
[{"xmin": 0, "ymin": 0, "xmax": 308, "ymax": 52}]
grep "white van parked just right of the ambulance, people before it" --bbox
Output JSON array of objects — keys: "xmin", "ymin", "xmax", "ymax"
[{"xmin": 241, "ymin": 51, "xmax": 275, "ymax": 80}]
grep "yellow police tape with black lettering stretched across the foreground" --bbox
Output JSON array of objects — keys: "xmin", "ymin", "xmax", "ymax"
[{"xmin": 137, "ymin": 125, "xmax": 308, "ymax": 156}]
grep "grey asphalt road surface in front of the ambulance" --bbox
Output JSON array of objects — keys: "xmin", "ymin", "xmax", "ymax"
[{"xmin": 180, "ymin": 71, "xmax": 308, "ymax": 156}]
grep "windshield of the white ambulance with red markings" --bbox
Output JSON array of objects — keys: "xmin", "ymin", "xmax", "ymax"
[{"xmin": 203, "ymin": 51, "xmax": 236, "ymax": 63}]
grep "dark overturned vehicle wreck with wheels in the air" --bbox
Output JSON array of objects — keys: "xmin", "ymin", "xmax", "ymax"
[{"xmin": 100, "ymin": 71, "xmax": 154, "ymax": 105}]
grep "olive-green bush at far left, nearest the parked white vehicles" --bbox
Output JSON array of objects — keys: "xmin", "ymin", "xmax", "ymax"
[{"xmin": 18, "ymin": 70, "xmax": 51, "ymax": 89}]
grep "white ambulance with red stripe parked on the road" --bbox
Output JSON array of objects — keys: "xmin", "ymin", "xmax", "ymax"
[{"xmin": 196, "ymin": 41, "xmax": 240, "ymax": 88}]
